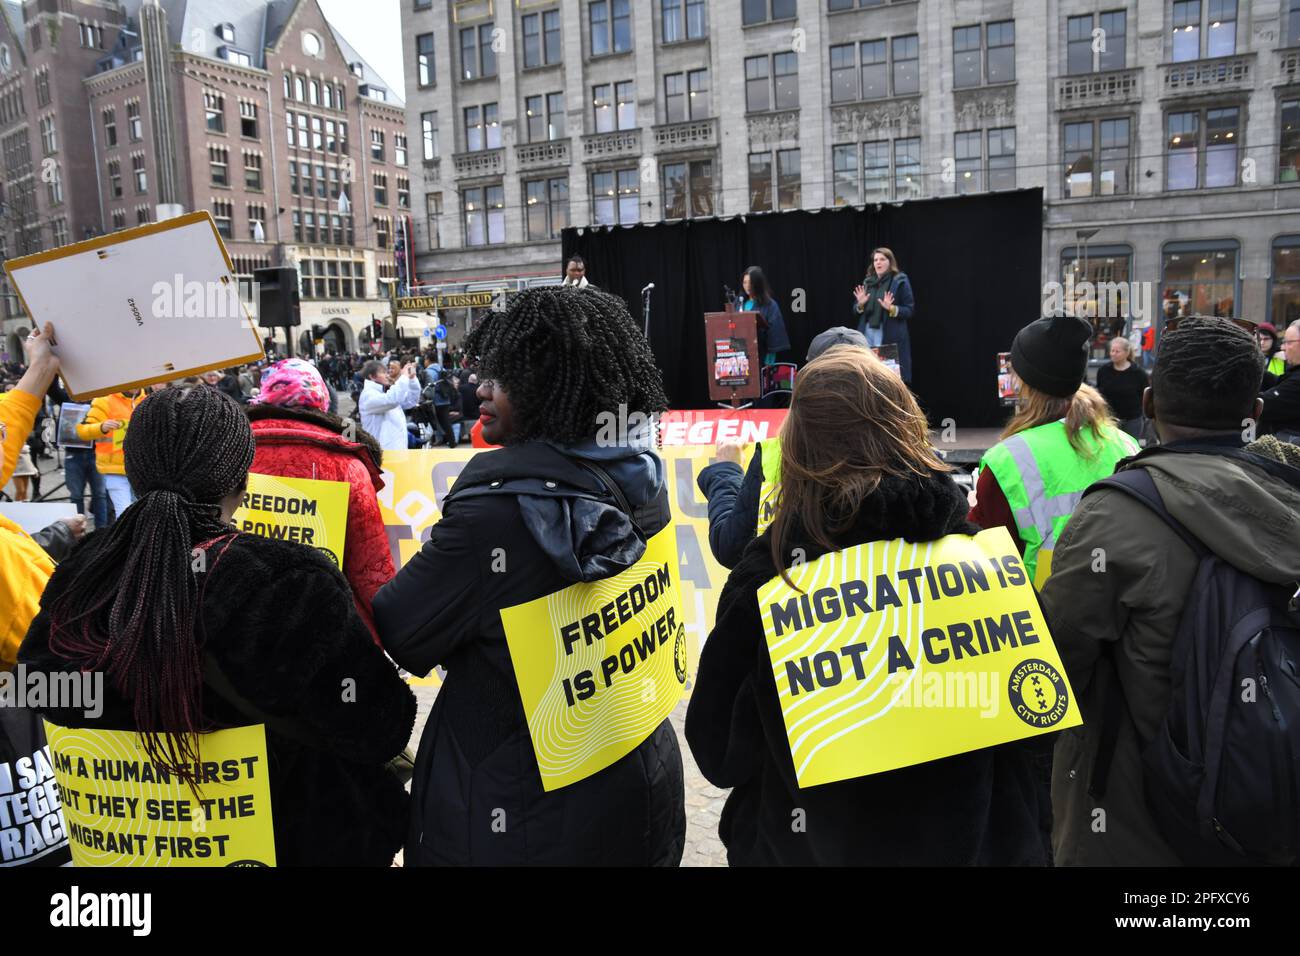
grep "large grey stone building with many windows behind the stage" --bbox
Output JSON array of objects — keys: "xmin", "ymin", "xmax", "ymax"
[{"xmin": 400, "ymin": 0, "xmax": 1300, "ymax": 335}]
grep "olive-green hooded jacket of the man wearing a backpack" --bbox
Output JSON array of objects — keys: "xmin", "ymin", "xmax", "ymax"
[{"xmin": 1041, "ymin": 438, "xmax": 1300, "ymax": 866}]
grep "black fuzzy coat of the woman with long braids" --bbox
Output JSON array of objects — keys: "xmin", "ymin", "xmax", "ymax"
[{"xmin": 18, "ymin": 532, "xmax": 415, "ymax": 866}]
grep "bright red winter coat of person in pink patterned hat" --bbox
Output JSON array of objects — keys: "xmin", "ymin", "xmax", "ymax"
[{"xmin": 248, "ymin": 405, "xmax": 397, "ymax": 644}]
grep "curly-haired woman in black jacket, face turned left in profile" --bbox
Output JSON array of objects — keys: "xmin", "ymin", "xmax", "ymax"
[{"xmin": 373, "ymin": 286, "xmax": 685, "ymax": 866}]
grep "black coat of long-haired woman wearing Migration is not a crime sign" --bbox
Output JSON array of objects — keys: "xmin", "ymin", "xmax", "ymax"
[{"xmin": 686, "ymin": 475, "xmax": 1047, "ymax": 866}]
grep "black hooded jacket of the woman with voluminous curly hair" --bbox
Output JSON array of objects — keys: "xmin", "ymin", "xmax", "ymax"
[{"xmin": 374, "ymin": 442, "xmax": 685, "ymax": 866}]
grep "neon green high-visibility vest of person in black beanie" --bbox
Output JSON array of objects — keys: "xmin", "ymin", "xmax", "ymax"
[{"xmin": 980, "ymin": 421, "xmax": 1141, "ymax": 588}]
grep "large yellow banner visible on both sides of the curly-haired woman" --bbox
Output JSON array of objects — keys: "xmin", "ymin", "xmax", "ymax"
[{"xmin": 378, "ymin": 446, "xmax": 728, "ymax": 693}]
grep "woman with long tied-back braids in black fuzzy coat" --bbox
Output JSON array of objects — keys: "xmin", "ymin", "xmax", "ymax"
[{"xmin": 18, "ymin": 386, "xmax": 415, "ymax": 866}]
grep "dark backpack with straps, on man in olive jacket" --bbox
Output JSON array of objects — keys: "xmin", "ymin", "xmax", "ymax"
[{"xmin": 1088, "ymin": 463, "xmax": 1300, "ymax": 866}]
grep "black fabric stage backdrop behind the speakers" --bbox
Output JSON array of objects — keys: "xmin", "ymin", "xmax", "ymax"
[{"xmin": 563, "ymin": 189, "xmax": 1043, "ymax": 428}]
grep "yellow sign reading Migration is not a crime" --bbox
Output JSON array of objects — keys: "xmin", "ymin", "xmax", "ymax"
[{"xmin": 758, "ymin": 528, "xmax": 1082, "ymax": 787}]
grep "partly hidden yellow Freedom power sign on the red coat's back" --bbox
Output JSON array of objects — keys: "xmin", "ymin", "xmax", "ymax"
[{"xmin": 234, "ymin": 472, "xmax": 351, "ymax": 567}]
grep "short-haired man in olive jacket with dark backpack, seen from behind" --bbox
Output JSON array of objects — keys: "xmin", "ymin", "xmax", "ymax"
[{"xmin": 1041, "ymin": 319, "xmax": 1300, "ymax": 866}]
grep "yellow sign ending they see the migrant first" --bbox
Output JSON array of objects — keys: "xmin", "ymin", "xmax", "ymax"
[{"xmin": 46, "ymin": 721, "xmax": 276, "ymax": 866}]
